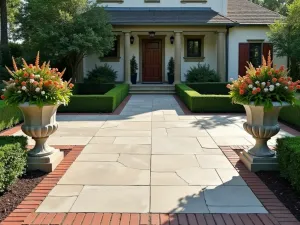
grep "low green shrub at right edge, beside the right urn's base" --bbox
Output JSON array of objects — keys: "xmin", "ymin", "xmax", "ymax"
[{"xmin": 276, "ymin": 137, "xmax": 300, "ymax": 192}]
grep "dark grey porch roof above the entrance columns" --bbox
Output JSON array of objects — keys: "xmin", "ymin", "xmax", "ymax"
[{"xmin": 105, "ymin": 7, "xmax": 235, "ymax": 25}]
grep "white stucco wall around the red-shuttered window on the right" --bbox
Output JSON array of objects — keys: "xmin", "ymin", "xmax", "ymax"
[{"xmin": 228, "ymin": 26, "xmax": 287, "ymax": 79}]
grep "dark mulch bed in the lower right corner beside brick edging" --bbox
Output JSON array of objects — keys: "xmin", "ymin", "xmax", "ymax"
[{"xmin": 256, "ymin": 172, "xmax": 300, "ymax": 221}]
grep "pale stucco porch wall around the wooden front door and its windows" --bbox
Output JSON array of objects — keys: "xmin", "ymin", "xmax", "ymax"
[{"xmin": 83, "ymin": 32, "xmax": 217, "ymax": 81}]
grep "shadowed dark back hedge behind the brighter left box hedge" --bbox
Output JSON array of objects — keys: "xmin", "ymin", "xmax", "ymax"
[{"xmin": 73, "ymin": 83, "xmax": 116, "ymax": 95}]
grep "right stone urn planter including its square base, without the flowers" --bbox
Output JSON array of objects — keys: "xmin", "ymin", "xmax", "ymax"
[{"xmin": 241, "ymin": 102, "xmax": 290, "ymax": 171}]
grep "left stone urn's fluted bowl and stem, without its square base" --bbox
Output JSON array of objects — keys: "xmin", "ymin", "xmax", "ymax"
[{"xmin": 19, "ymin": 103, "xmax": 59, "ymax": 157}]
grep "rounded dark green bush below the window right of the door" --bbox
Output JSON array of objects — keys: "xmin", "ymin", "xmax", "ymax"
[{"xmin": 185, "ymin": 63, "xmax": 220, "ymax": 83}]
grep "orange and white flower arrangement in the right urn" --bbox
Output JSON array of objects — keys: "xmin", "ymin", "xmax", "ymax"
[{"xmin": 227, "ymin": 53, "xmax": 300, "ymax": 109}]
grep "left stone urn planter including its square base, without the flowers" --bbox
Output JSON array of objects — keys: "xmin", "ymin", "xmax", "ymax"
[{"xmin": 19, "ymin": 103, "xmax": 63, "ymax": 172}]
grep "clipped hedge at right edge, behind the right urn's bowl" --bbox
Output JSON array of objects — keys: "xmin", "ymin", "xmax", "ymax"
[{"xmin": 279, "ymin": 101, "xmax": 300, "ymax": 131}]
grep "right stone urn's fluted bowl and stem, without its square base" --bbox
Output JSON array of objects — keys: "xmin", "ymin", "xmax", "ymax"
[{"xmin": 244, "ymin": 102, "xmax": 290, "ymax": 157}]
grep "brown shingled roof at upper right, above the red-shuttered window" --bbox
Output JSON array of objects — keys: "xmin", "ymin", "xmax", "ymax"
[{"xmin": 227, "ymin": 0, "xmax": 281, "ymax": 25}]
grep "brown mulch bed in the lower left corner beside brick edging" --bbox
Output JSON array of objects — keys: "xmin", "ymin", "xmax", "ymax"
[{"xmin": 0, "ymin": 171, "xmax": 46, "ymax": 222}]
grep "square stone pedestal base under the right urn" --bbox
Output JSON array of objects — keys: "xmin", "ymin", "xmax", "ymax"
[{"xmin": 240, "ymin": 150, "xmax": 278, "ymax": 172}]
